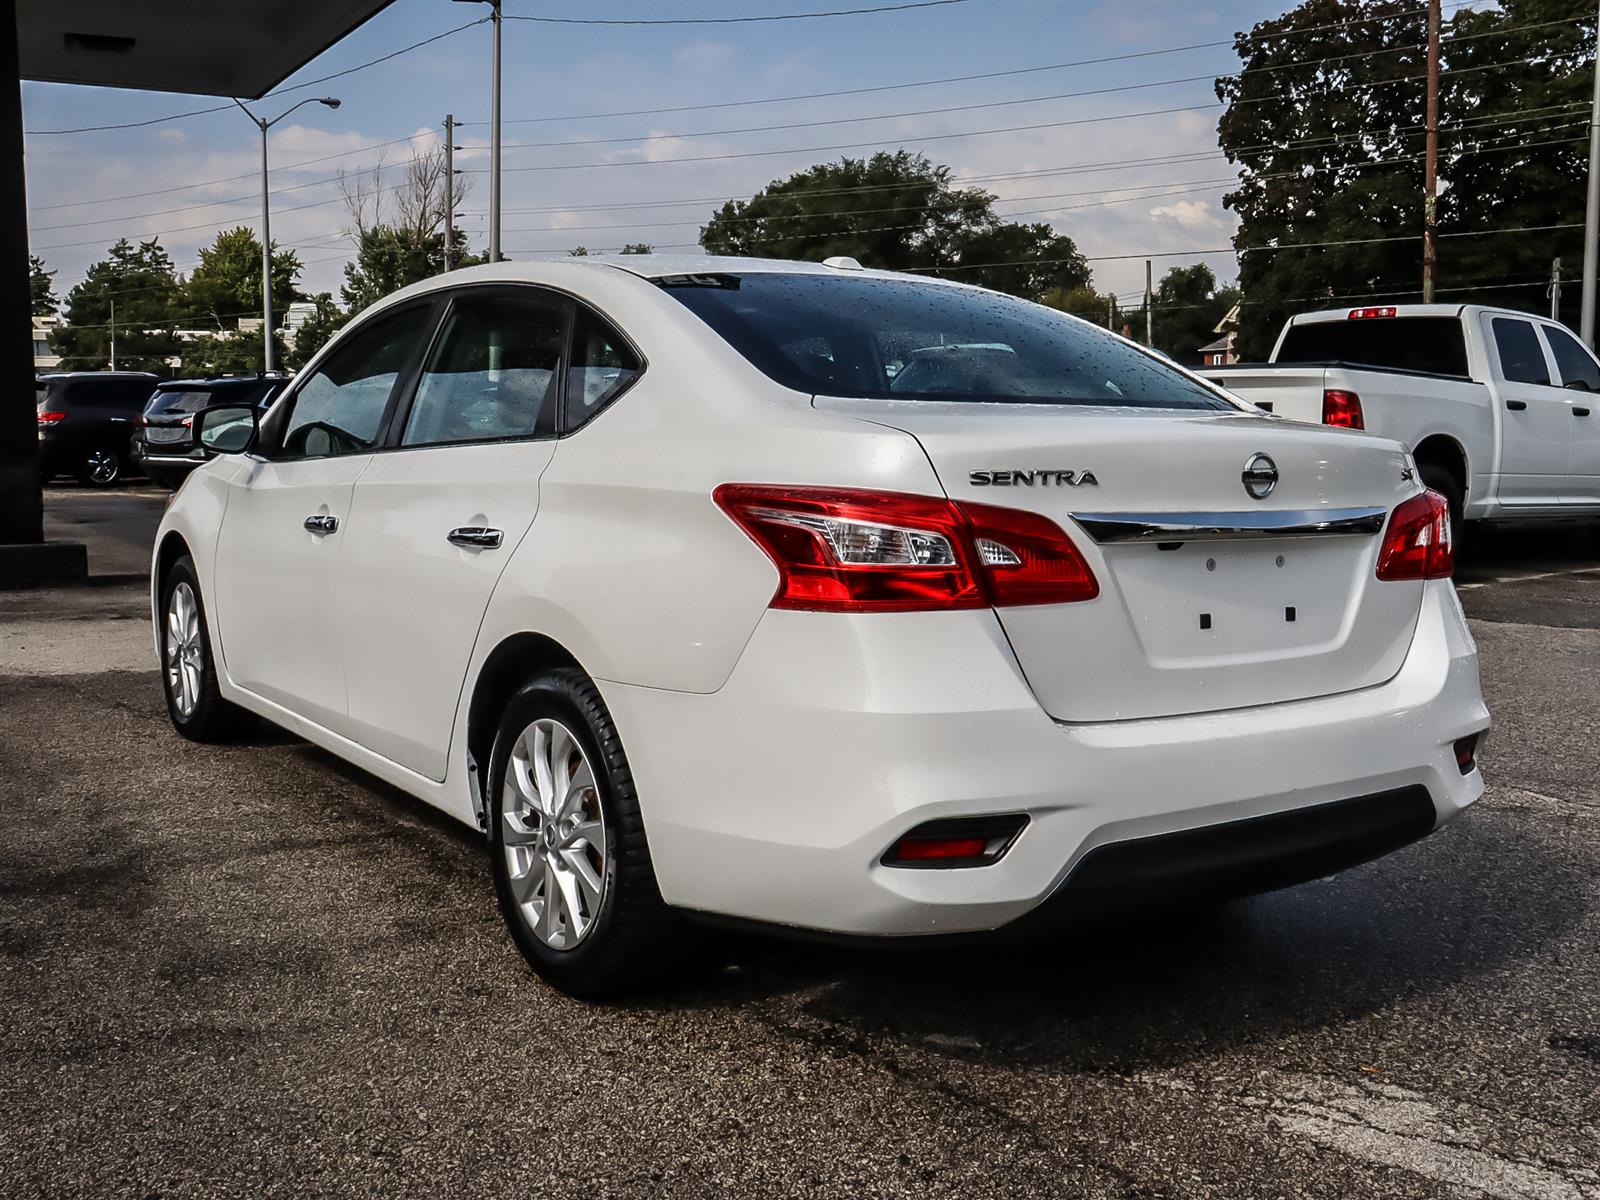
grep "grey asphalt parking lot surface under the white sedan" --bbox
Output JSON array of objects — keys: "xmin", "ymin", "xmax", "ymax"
[{"xmin": 0, "ymin": 488, "xmax": 1600, "ymax": 1200}]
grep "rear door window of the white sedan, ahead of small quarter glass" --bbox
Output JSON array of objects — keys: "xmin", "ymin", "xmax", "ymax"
[{"xmin": 400, "ymin": 293, "xmax": 568, "ymax": 446}]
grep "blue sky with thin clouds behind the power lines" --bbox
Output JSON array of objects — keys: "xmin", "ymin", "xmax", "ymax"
[{"xmin": 22, "ymin": 0, "xmax": 1285, "ymax": 310}]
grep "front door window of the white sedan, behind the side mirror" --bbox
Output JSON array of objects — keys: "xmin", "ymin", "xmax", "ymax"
[{"xmin": 283, "ymin": 304, "xmax": 434, "ymax": 458}]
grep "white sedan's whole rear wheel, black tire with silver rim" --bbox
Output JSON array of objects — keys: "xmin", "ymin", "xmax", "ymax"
[{"xmin": 490, "ymin": 669, "xmax": 678, "ymax": 998}]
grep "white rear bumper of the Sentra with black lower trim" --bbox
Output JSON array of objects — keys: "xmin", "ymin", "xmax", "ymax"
[{"xmin": 602, "ymin": 581, "xmax": 1488, "ymax": 934}]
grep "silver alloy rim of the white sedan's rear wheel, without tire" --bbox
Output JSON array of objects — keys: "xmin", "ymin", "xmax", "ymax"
[{"xmin": 501, "ymin": 718, "xmax": 610, "ymax": 950}]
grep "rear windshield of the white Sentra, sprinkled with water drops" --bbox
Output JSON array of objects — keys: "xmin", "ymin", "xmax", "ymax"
[{"xmin": 661, "ymin": 274, "xmax": 1234, "ymax": 411}]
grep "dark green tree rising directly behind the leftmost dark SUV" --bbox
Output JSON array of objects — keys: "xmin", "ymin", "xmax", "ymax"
[{"xmin": 50, "ymin": 238, "xmax": 182, "ymax": 373}]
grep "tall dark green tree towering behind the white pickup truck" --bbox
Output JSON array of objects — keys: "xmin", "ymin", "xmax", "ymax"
[{"xmin": 1218, "ymin": 0, "xmax": 1595, "ymax": 358}]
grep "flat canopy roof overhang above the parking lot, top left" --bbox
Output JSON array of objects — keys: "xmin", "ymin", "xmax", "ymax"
[{"xmin": 16, "ymin": 0, "xmax": 392, "ymax": 99}]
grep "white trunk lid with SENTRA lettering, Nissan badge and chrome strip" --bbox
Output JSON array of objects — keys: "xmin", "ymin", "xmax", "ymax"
[{"xmin": 814, "ymin": 398, "xmax": 1422, "ymax": 722}]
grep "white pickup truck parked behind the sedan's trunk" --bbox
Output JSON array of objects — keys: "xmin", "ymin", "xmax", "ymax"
[{"xmin": 1198, "ymin": 304, "xmax": 1600, "ymax": 530}]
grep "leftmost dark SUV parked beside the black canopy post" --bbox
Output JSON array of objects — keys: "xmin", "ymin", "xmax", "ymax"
[{"xmin": 34, "ymin": 371, "xmax": 155, "ymax": 488}]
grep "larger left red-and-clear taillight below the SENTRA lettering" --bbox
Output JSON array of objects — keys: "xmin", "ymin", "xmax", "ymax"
[{"xmin": 712, "ymin": 483, "xmax": 1099, "ymax": 613}]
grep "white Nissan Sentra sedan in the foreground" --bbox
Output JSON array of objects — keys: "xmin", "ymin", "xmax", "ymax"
[{"xmin": 152, "ymin": 256, "xmax": 1488, "ymax": 995}]
